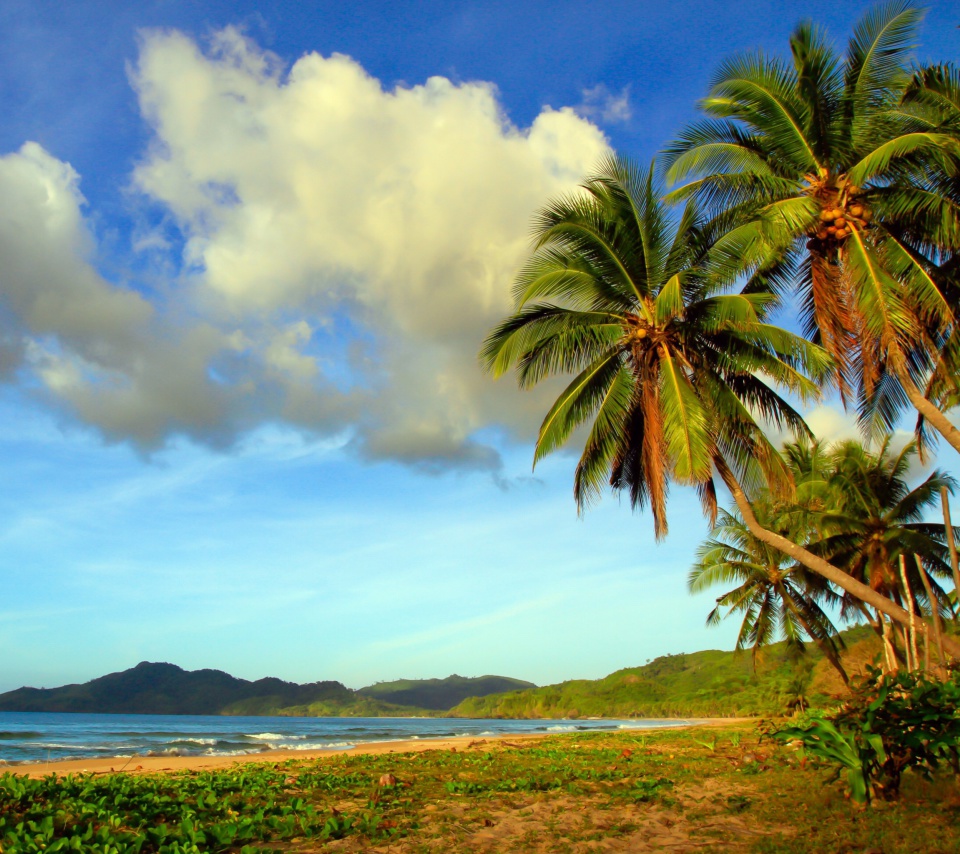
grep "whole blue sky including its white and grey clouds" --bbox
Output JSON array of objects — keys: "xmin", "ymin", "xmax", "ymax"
[{"xmin": 0, "ymin": 0, "xmax": 960, "ymax": 691}]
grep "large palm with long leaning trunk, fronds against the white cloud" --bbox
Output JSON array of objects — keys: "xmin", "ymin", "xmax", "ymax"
[{"xmin": 481, "ymin": 158, "xmax": 960, "ymax": 657}]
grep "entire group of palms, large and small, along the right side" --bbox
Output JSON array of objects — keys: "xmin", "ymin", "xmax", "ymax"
[{"xmin": 480, "ymin": 2, "xmax": 960, "ymax": 680}]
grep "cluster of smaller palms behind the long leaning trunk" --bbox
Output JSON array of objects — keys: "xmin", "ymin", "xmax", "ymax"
[{"xmin": 690, "ymin": 441, "xmax": 954, "ymax": 679}]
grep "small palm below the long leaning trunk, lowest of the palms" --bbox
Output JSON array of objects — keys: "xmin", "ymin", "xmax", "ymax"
[{"xmin": 688, "ymin": 508, "xmax": 849, "ymax": 684}]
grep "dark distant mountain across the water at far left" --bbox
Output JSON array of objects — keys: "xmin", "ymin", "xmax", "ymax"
[{"xmin": 0, "ymin": 661, "xmax": 410, "ymax": 716}]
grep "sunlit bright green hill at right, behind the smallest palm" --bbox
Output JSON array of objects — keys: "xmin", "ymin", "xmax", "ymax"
[{"xmin": 449, "ymin": 626, "xmax": 879, "ymax": 718}]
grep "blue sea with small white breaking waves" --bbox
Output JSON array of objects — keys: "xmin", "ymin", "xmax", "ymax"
[{"xmin": 0, "ymin": 712, "xmax": 687, "ymax": 765}]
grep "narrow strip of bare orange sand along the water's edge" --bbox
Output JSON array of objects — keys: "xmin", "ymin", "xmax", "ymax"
[{"xmin": 0, "ymin": 718, "xmax": 754, "ymax": 779}]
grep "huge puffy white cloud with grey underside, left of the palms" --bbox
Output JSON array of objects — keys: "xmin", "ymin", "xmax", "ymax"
[{"xmin": 0, "ymin": 29, "xmax": 607, "ymax": 470}]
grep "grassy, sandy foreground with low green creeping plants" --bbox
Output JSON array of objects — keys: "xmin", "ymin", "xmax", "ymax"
[{"xmin": 0, "ymin": 725, "xmax": 960, "ymax": 854}]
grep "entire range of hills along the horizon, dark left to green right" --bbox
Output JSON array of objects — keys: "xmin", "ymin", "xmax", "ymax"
[{"xmin": 0, "ymin": 626, "xmax": 892, "ymax": 718}]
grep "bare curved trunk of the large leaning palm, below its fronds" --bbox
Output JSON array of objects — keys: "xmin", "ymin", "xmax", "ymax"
[{"xmin": 714, "ymin": 458, "xmax": 960, "ymax": 659}]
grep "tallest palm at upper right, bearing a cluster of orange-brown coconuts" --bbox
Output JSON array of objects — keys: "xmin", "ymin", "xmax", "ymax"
[{"xmin": 666, "ymin": 2, "xmax": 960, "ymax": 451}]
